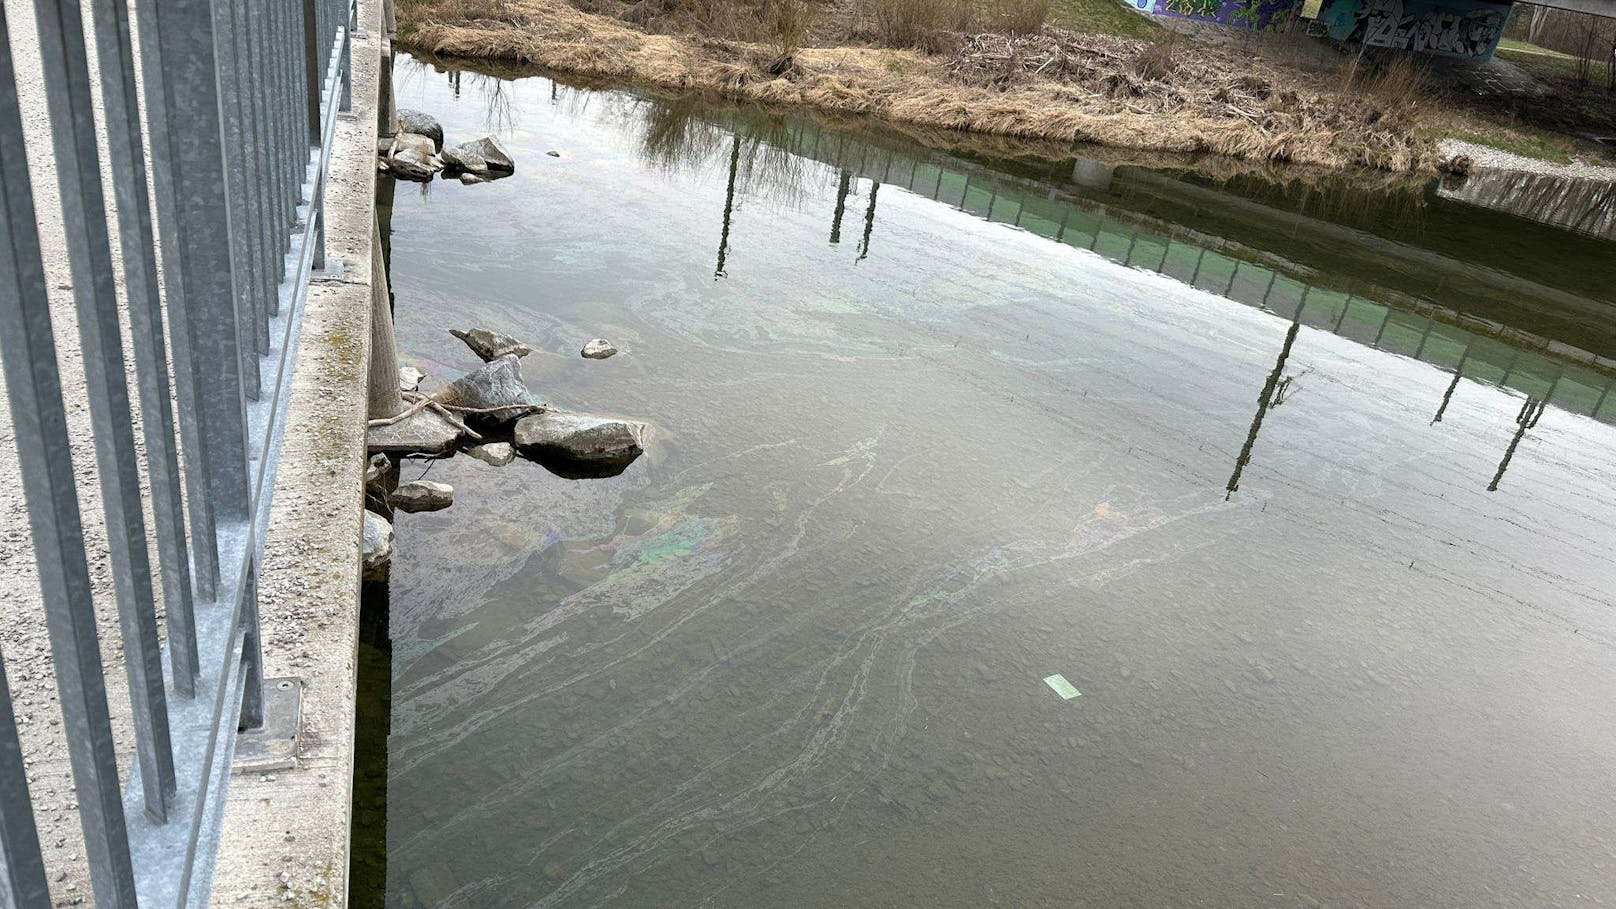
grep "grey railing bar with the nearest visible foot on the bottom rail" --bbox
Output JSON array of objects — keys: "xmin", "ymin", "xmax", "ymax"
[{"xmin": 34, "ymin": 0, "xmax": 175, "ymax": 822}]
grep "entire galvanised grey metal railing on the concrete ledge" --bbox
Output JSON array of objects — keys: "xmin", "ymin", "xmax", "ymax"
[{"xmin": 0, "ymin": 0, "xmax": 357, "ymax": 909}]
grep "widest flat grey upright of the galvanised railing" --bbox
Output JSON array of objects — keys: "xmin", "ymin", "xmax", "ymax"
[{"xmin": 142, "ymin": 0, "xmax": 247, "ymax": 521}]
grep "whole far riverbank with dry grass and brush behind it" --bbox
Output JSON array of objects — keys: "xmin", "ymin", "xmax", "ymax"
[{"xmin": 398, "ymin": 0, "xmax": 1577, "ymax": 173}]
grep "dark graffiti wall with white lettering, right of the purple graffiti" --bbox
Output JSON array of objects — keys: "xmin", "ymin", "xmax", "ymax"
[{"xmin": 1319, "ymin": 0, "xmax": 1509, "ymax": 60}]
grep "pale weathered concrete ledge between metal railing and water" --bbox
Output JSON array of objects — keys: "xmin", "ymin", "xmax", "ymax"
[{"xmin": 212, "ymin": 0, "xmax": 391, "ymax": 907}]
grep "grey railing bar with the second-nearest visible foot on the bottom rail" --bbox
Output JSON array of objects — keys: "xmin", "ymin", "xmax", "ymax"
[{"xmin": 90, "ymin": 0, "xmax": 199, "ymax": 697}]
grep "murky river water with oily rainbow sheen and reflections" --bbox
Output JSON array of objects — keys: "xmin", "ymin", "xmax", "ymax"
[{"xmin": 356, "ymin": 60, "xmax": 1616, "ymax": 907}]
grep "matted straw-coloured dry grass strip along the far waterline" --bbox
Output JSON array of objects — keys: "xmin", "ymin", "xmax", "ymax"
[{"xmin": 399, "ymin": 0, "xmax": 1437, "ymax": 171}]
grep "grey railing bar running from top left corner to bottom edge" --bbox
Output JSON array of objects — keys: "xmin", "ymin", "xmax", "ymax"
[{"xmin": 0, "ymin": 5, "xmax": 136, "ymax": 907}]
